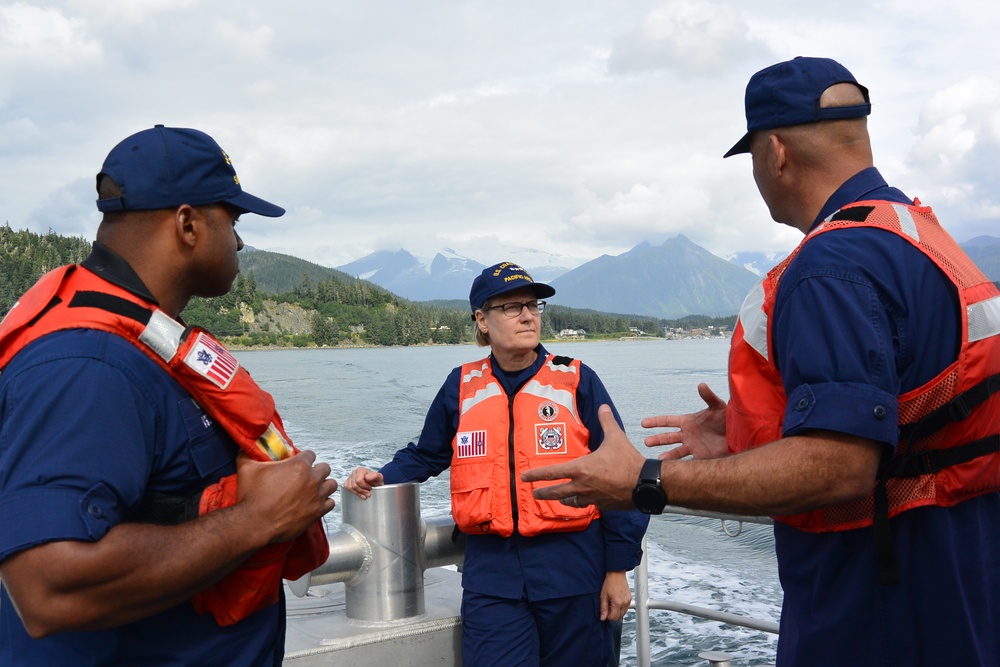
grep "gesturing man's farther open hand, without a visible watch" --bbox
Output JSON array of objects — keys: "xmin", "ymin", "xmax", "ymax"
[{"xmin": 642, "ymin": 382, "xmax": 729, "ymax": 461}]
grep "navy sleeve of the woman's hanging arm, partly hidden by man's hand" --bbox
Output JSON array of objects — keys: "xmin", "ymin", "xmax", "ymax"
[{"xmin": 577, "ymin": 364, "xmax": 649, "ymax": 572}]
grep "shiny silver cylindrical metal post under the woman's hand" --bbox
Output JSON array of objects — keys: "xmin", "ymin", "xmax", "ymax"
[{"xmin": 341, "ymin": 483, "xmax": 424, "ymax": 623}]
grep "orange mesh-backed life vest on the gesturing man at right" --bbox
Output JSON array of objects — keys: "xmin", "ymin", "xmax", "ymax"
[{"xmin": 726, "ymin": 201, "xmax": 1000, "ymax": 540}]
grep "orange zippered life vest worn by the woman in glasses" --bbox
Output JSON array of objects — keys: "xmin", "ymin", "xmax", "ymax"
[{"xmin": 451, "ymin": 355, "xmax": 600, "ymax": 537}]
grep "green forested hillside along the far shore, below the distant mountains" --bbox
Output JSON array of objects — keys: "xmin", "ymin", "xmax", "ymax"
[{"xmin": 0, "ymin": 225, "xmax": 734, "ymax": 347}]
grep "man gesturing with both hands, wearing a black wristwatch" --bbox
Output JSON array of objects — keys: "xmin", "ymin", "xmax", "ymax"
[{"xmin": 523, "ymin": 58, "xmax": 1000, "ymax": 667}]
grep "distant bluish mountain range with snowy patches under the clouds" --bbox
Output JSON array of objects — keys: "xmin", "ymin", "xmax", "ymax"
[{"xmin": 241, "ymin": 236, "xmax": 1000, "ymax": 319}]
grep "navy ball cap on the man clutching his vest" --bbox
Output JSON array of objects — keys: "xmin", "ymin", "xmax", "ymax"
[{"xmin": 97, "ymin": 125, "xmax": 285, "ymax": 218}]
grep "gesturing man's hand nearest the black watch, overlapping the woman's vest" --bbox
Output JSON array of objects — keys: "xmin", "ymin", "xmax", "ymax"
[{"xmin": 521, "ymin": 405, "xmax": 645, "ymax": 509}]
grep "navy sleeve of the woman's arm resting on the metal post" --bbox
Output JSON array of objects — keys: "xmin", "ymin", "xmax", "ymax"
[{"xmin": 379, "ymin": 367, "xmax": 462, "ymax": 484}]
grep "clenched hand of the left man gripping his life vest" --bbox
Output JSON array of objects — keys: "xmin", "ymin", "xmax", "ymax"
[{"xmin": 236, "ymin": 450, "xmax": 337, "ymax": 542}]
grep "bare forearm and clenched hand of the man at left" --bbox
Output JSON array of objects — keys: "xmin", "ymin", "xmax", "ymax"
[{"xmin": 0, "ymin": 451, "xmax": 337, "ymax": 638}]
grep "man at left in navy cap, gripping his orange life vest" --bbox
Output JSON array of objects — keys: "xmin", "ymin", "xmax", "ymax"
[{"xmin": 0, "ymin": 125, "xmax": 337, "ymax": 665}]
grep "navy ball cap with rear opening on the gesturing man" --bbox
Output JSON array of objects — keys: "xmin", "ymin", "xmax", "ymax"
[{"xmin": 723, "ymin": 56, "xmax": 872, "ymax": 157}]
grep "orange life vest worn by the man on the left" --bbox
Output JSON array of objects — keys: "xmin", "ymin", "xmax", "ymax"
[{"xmin": 0, "ymin": 265, "xmax": 329, "ymax": 625}]
